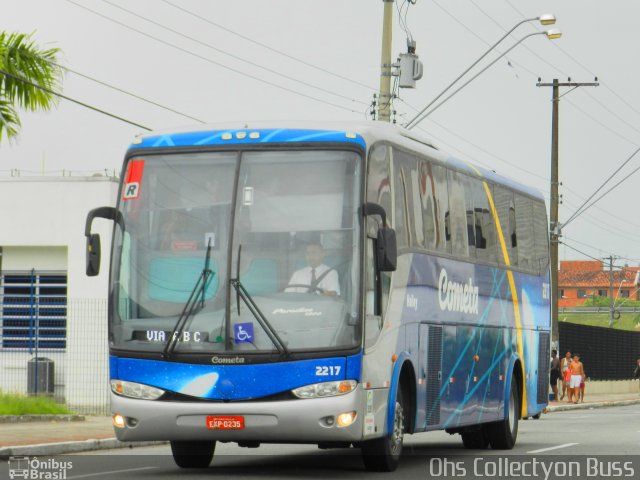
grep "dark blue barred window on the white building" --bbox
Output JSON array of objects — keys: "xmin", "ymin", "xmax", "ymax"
[{"xmin": 0, "ymin": 270, "xmax": 67, "ymax": 351}]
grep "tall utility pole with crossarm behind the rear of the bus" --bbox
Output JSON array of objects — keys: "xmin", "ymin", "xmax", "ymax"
[{"xmin": 536, "ymin": 78, "xmax": 599, "ymax": 351}]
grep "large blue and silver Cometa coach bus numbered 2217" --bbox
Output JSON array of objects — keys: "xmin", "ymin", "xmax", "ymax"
[{"xmin": 85, "ymin": 122, "xmax": 550, "ymax": 471}]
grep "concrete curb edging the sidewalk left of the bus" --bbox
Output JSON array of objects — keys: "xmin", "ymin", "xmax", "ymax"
[{"xmin": 0, "ymin": 438, "xmax": 167, "ymax": 459}]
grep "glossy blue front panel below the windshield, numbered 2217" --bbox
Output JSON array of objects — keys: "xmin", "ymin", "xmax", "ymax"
[{"xmin": 109, "ymin": 355, "xmax": 362, "ymax": 400}]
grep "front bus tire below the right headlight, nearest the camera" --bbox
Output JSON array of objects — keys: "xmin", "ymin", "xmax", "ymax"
[{"xmin": 360, "ymin": 387, "xmax": 405, "ymax": 472}]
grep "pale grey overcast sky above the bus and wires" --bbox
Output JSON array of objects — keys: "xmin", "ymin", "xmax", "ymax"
[{"xmin": 0, "ymin": 0, "xmax": 640, "ymax": 265}]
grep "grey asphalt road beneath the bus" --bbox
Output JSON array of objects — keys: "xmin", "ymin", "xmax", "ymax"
[{"xmin": 5, "ymin": 405, "xmax": 640, "ymax": 480}]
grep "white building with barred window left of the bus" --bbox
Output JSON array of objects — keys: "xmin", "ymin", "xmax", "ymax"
[{"xmin": 0, "ymin": 175, "xmax": 118, "ymax": 411}]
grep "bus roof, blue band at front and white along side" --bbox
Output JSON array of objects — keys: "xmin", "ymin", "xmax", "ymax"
[{"xmin": 130, "ymin": 121, "xmax": 543, "ymax": 200}]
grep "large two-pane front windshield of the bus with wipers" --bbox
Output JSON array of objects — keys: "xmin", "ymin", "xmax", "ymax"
[{"xmin": 110, "ymin": 150, "xmax": 362, "ymax": 354}]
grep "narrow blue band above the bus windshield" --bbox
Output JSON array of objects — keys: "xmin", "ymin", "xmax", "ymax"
[{"xmin": 130, "ymin": 129, "xmax": 366, "ymax": 149}]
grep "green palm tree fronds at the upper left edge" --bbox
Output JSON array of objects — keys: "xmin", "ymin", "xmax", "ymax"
[{"xmin": 0, "ymin": 32, "xmax": 62, "ymax": 141}]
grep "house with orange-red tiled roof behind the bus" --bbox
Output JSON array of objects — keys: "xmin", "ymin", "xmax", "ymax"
[{"xmin": 558, "ymin": 260, "xmax": 640, "ymax": 308}]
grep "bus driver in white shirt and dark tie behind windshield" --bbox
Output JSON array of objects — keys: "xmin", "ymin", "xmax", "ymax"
[{"xmin": 285, "ymin": 243, "xmax": 340, "ymax": 296}]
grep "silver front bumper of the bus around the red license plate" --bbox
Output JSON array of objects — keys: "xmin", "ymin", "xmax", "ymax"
[{"xmin": 111, "ymin": 385, "xmax": 365, "ymax": 443}]
